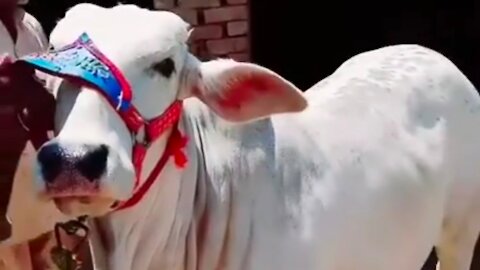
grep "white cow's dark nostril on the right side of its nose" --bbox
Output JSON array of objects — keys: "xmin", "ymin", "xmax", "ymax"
[{"xmin": 76, "ymin": 144, "xmax": 108, "ymax": 182}]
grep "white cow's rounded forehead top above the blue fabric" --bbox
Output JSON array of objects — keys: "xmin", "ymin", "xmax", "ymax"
[{"xmin": 50, "ymin": 4, "xmax": 189, "ymax": 58}]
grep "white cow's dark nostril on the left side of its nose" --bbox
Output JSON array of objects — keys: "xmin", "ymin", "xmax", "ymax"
[{"xmin": 37, "ymin": 143, "xmax": 64, "ymax": 183}]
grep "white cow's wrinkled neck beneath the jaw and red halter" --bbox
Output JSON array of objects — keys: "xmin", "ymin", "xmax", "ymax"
[{"xmin": 91, "ymin": 99, "xmax": 252, "ymax": 270}]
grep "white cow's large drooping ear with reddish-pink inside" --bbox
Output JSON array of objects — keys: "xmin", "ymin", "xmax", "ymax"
[{"xmin": 193, "ymin": 59, "xmax": 307, "ymax": 122}]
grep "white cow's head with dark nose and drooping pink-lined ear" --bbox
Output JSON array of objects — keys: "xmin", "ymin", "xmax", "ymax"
[{"xmin": 24, "ymin": 4, "xmax": 306, "ymax": 215}]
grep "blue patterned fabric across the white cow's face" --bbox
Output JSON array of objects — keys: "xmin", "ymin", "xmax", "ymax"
[{"xmin": 19, "ymin": 33, "xmax": 131, "ymax": 111}]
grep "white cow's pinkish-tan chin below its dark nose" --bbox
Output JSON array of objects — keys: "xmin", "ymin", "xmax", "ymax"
[{"xmin": 53, "ymin": 196, "xmax": 116, "ymax": 217}]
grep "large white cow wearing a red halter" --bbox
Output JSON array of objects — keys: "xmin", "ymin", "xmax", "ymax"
[{"xmin": 23, "ymin": 4, "xmax": 480, "ymax": 270}]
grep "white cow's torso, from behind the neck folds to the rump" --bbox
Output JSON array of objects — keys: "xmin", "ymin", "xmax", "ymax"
[{"xmin": 189, "ymin": 45, "xmax": 480, "ymax": 270}]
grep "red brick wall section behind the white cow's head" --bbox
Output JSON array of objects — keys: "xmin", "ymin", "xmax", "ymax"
[{"xmin": 154, "ymin": 0, "xmax": 250, "ymax": 61}]
